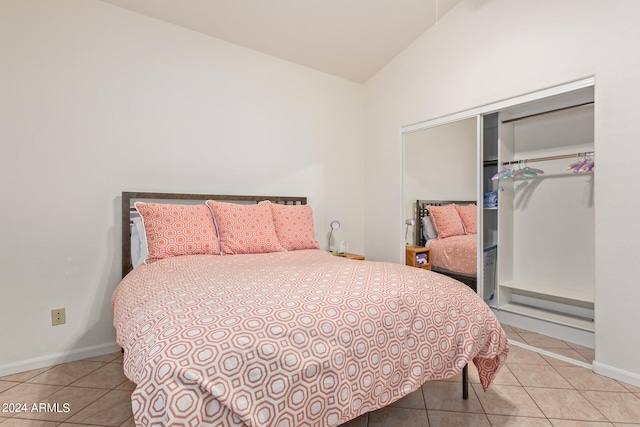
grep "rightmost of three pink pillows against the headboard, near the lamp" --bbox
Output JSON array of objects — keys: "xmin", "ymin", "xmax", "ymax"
[{"xmin": 269, "ymin": 203, "xmax": 320, "ymax": 251}]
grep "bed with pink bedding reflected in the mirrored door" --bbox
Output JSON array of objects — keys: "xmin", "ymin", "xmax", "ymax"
[{"xmin": 414, "ymin": 200, "xmax": 478, "ymax": 291}]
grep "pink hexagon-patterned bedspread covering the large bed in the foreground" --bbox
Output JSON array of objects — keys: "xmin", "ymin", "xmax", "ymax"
[{"xmin": 112, "ymin": 250, "xmax": 508, "ymax": 427}]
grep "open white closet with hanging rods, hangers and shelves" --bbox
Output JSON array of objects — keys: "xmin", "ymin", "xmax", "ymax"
[{"xmin": 478, "ymin": 79, "xmax": 597, "ymax": 348}]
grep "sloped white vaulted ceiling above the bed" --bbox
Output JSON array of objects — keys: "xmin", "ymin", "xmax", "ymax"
[{"xmin": 102, "ymin": 0, "xmax": 460, "ymax": 83}]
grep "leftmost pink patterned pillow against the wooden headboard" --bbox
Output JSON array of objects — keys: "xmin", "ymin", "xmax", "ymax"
[{"xmin": 134, "ymin": 202, "xmax": 220, "ymax": 264}]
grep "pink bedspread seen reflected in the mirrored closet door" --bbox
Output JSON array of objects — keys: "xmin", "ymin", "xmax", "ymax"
[{"xmin": 429, "ymin": 234, "xmax": 478, "ymax": 275}]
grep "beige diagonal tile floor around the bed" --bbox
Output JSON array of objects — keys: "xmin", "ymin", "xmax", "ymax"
[{"xmin": 0, "ymin": 326, "xmax": 640, "ymax": 427}]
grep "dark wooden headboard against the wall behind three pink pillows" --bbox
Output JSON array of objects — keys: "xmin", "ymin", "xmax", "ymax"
[{"xmin": 122, "ymin": 191, "xmax": 307, "ymax": 278}]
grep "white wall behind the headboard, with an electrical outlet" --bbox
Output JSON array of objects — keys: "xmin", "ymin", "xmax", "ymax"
[{"xmin": 0, "ymin": 0, "xmax": 364, "ymax": 375}]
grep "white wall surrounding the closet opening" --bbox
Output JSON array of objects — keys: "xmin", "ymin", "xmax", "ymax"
[{"xmin": 365, "ymin": 0, "xmax": 640, "ymax": 385}]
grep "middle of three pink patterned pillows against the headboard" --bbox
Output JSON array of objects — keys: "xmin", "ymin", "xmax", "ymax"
[{"xmin": 207, "ymin": 200, "xmax": 285, "ymax": 254}]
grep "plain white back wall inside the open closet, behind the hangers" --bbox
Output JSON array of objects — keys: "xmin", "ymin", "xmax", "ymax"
[{"xmin": 505, "ymin": 106, "xmax": 595, "ymax": 293}]
